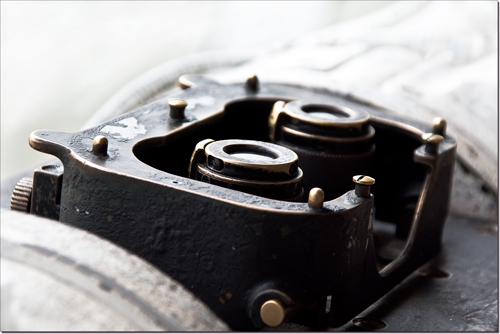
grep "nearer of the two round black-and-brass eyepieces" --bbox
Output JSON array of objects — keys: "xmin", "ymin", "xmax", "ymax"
[{"xmin": 189, "ymin": 139, "xmax": 304, "ymax": 201}]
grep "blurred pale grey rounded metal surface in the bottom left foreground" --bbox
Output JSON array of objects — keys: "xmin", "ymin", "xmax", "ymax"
[{"xmin": 1, "ymin": 209, "xmax": 228, "ymax": 331}]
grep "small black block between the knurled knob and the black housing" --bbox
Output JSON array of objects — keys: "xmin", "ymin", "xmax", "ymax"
[{"xmin": 31, "ymin": 165, "xmax": 64, "ymax": 220}]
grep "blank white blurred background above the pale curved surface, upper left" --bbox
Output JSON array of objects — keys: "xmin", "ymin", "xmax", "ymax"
[{"xmin": 0, "ymin": 1, "xmax": 391, "ymax": 178}]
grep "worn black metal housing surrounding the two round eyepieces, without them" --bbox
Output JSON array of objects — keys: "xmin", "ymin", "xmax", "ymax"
[{"xmin": 30, "ymin": 76, "xmax": 456, "ymax": 330}]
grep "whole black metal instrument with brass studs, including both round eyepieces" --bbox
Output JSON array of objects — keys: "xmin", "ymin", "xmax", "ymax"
[{"xmin": 17, "ymin": 75, "xmax": 456, "ymax": 330}]
